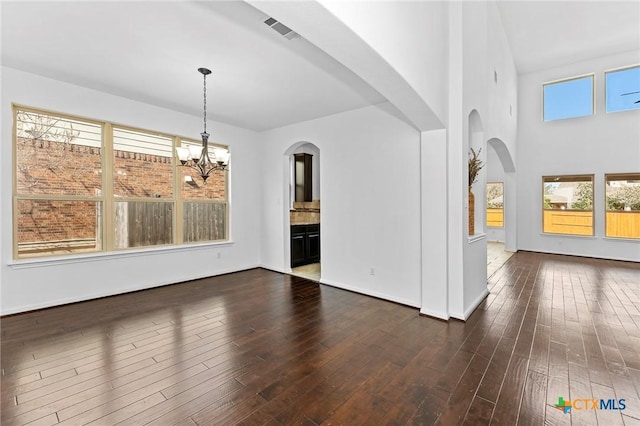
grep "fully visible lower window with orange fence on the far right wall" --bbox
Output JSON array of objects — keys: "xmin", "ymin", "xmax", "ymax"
[{"xmin": 542, "ymin": 175, "xmax": 593, "ymax": 235}]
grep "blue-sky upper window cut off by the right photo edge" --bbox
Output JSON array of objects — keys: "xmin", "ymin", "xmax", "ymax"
[{"xmin": 605, "ymin": 67, "xmax": 640, "ymax": 112}]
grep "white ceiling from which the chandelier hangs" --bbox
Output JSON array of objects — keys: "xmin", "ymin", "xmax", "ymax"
[{"xmin": 1, "ymin": 1, "xmax": 385, "ymax": 130}]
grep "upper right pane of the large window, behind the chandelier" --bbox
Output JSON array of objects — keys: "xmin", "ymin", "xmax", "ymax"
[{"xmin": 180, "ymin": 140, "xmax": 227, "ymax": 201}]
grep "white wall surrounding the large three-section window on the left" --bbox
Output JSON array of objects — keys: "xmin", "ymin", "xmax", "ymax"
[{"xmin": 0, "ymin": 67, "xmax": 260, "ymax": 315}]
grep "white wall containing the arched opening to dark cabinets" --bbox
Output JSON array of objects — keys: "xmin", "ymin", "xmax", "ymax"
[{"xmin": 261, "ymin": 104, "xmax": 421, "ymax": 306}]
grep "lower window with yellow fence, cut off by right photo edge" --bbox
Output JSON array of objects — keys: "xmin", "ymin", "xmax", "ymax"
[{"xmin": 605, "ymin": 173, "xmax": 640, "ymax": 239}]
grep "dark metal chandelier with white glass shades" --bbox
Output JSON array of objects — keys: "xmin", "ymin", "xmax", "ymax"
[{"xmin": 176, "ymin": 68, "xmax": 230, "ymax": 183}]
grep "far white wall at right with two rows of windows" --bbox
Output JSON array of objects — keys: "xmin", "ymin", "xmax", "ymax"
[{"xmin": 517, "ymin": 51, "xmax": 640, "ymax": 261}]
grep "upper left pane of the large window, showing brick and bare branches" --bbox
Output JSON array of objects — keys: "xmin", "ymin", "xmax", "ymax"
[{"xmin": 15, "ymin": 110, "xmax": 102, "ymax": 196}]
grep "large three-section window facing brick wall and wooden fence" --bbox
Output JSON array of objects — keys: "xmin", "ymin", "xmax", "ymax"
[{"xmin": 14, "ymin": 107, "xmax": 228, "ymax": 258}]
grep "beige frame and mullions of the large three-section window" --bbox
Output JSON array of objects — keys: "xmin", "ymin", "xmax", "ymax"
[{"xmin": 11, "ymin": 103, "xmax": 231, "ymax": 261}]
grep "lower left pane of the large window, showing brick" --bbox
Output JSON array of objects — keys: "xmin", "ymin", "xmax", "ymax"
[{"xmin": 17, "ymin": 200, "xmax": 102, "ymax": 257}]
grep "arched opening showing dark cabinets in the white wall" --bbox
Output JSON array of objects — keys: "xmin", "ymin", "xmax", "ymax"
[{"xmin": 283, "ymin": 141, "xmax": 321, "ymax": 281}]
